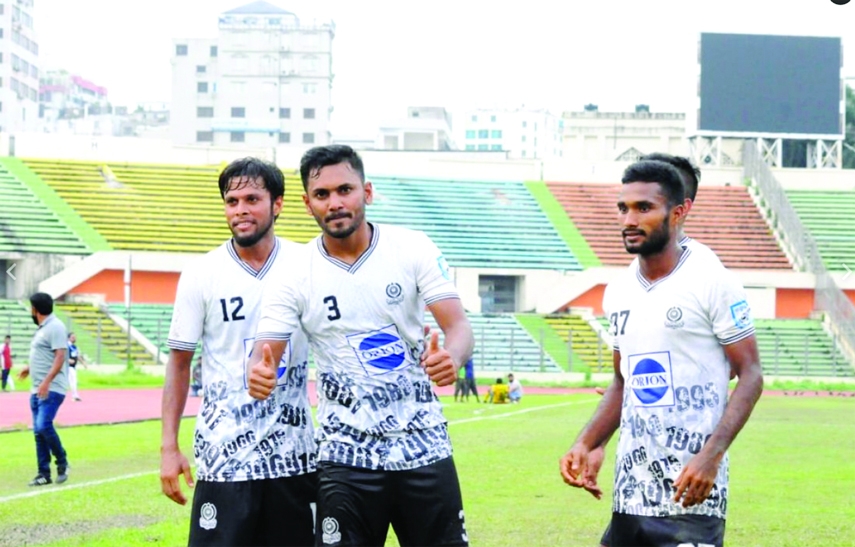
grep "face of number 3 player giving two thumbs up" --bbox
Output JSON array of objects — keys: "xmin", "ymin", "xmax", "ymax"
[{"xmin": 303, "ymin": 161, "xmax": 373, "ymax": 239}]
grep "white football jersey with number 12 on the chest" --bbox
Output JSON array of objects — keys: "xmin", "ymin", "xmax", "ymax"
[{"xmin": 168, "ymin": 238, "xmax": 317, "ymax": 481}]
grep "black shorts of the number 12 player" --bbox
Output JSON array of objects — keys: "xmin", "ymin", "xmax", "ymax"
[{"xmin": 188, "ymin": 473, "xmax": 318, "ymax": 547}]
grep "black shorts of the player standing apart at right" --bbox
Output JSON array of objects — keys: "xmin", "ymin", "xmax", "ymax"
[{"xmin": 600, "ymin": 513, "xmax": 725, "ymax": 547}]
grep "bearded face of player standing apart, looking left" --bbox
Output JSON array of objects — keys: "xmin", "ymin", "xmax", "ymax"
[{"xmin": 618, "ymin": 182, "xmax": 684, "ymax": 256}]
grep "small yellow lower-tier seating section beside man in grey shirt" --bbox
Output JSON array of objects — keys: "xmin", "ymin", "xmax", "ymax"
[{"xmin": 57, "ymin": 303, "xmax": 155, "ymax": 365}]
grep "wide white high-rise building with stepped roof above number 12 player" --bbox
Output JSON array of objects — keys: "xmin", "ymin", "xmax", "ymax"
[{"xmin": 170, "ymin": 1, "xmax": 335, "ymax": 147}]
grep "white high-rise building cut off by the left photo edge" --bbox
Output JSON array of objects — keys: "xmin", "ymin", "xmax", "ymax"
[{"xmin": 0, "ymin": 0, "xmax": 39, "ymax": 133}]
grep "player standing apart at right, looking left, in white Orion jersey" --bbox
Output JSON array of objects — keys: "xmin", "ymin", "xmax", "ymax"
[{"xmin": 561, "ymin": 161, "xmax": 763, "ymax": 547}]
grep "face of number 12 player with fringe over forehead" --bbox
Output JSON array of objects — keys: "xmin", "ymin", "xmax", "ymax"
[{"xmin": 223, "ymin": 177, "xmax": 282, "ymax": 247}]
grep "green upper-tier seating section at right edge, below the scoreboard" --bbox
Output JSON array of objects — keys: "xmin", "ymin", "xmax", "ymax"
[{"xmin": 786, "ymin": 190, "xmax": 855, "ymax": 271}]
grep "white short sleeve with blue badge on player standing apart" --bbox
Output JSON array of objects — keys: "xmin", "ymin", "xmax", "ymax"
[{"xmin": 709, "ymin": 270, "xmax": 754, "ymax": 345}]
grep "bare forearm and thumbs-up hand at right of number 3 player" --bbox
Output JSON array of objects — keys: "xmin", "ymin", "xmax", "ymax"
[{"xmin": 422, "ymin": 298, "xmax": 475, "ymax": 386}]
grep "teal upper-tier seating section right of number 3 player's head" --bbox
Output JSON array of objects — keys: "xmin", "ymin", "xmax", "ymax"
[{"xmin": 368, "ymin": 177, "xmax": 582, "ymax": 271}]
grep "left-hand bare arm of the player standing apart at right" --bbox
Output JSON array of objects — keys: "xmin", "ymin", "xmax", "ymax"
[{"xmin": 559, "ymin": 350, "xmax": 624, "ymax": 498}]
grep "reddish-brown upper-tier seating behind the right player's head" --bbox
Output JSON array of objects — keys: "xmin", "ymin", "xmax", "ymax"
[{"xmin": 547, "ymin": 182, "xmax": 792, "ymax": 269}]
